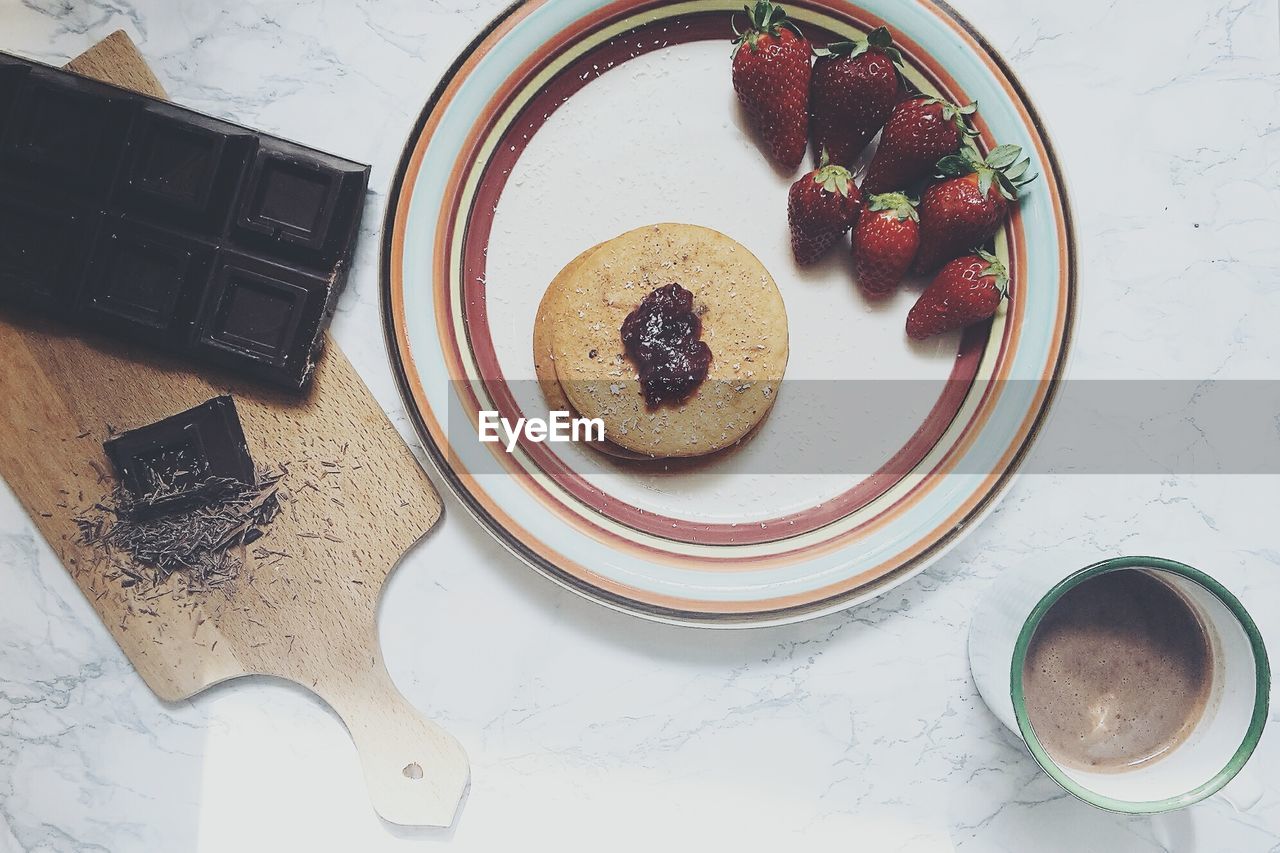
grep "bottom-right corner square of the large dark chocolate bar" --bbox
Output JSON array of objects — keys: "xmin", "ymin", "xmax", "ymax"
[{"xmin": 195, "ymin": 252, "xmax": 333, "ymax": 386}]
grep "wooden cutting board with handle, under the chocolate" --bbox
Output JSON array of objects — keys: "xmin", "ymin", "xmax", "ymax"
[{"xmin": 0, "ymin": 32, "xmax": 468, "ymax": 826}]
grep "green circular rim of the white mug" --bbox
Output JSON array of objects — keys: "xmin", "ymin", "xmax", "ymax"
[{"xmin": 1009, "ymin": 556, "xmax": 1271, "ymax": 815}]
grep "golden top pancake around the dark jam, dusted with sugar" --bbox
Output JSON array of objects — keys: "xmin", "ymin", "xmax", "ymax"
[{"xmin": 547, "ymin": 223, "xmax": 787, "ymax": 457}]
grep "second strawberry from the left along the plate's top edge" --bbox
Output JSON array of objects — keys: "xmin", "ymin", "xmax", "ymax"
[{"xmin": 809, "ymin": 27, "xmax": 902, "ymax": 167}]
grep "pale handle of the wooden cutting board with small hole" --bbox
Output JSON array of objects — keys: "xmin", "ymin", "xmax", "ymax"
[{"xmin": 306, "ymin": 644, "xmax": 471, "ymax": 826}]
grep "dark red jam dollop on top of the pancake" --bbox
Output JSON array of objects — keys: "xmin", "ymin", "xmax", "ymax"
[{"xmin": 622, "ymin": 283, "xmax": 712, "ymax": 409}]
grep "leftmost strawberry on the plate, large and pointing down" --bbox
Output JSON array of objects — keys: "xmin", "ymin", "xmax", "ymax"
[{"xmin": 733, "ymin": 0, "xmax": 808, "ymax": 169}]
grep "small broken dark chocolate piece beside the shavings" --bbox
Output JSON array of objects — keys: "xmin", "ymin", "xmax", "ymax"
[{"xmin": 102, "ymin": 397, "xmax": 256, "ymax": 517}]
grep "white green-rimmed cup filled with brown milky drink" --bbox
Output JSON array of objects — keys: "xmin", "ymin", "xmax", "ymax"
[{"xmin": 969, "ymin": 557, "xmax": 1270, "ymax": 815}]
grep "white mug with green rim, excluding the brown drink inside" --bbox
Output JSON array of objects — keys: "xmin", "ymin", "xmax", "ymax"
[{"xmin": 969, "ymin": 557, "xmax": 1271, "ymax": 815}]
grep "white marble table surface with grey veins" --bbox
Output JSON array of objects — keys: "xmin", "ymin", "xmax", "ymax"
[{"xmin": 0, "ymin": 0, "xmax": 1280, "ymax": 853}]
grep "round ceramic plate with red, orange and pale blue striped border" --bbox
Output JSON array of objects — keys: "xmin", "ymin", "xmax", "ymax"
[{"xmin": 383, "ymin": 0, "xmax": 1074, "ymax": 625}]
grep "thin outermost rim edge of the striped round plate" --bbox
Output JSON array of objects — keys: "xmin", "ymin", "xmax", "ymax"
[{"xmin": 379, "ymin": 0, "xmax": 1079, "ymax": 628}]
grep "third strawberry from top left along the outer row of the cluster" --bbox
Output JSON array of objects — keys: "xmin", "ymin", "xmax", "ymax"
[{"xmin": 863, "ymin": 95, "xmax": 978, "ymax": 193}]
